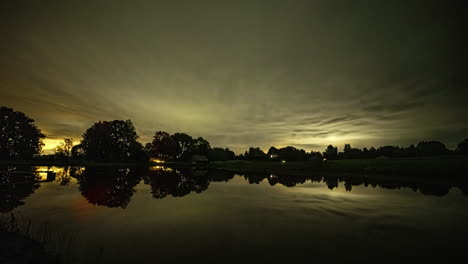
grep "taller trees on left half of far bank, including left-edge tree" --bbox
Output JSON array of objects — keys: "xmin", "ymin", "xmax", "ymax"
[{"xmin": 0, "ymin": 107, "xmax": 235, "ymax": 162}]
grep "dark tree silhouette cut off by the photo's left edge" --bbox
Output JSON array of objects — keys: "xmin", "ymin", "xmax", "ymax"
[{"xmin": 0, "ymin": 107, "xmax": 45, "ymax": 160}]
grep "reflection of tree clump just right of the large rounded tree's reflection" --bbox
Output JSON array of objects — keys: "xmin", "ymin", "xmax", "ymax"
[{"xmin": 144, "ymin": 168, "xmax": 210, "ymax": 199}]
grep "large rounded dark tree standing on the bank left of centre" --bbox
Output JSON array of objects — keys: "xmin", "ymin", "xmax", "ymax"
[{"xmin": 81, "ymin": 120, "xmax": 145, "ymax": 161}]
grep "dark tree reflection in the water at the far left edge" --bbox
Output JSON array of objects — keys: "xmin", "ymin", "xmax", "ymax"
[{"xmin": 0, "ymin": 167, "xmax": 39, "ymax": 213}]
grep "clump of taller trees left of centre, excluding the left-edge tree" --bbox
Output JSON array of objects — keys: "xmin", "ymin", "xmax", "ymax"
[{"xmin": 45, "ymin": 120, "xmax": 235, "ymax": 162}]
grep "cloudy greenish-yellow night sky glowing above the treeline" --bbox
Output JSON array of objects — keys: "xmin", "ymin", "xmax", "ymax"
[{"xmin": 0, "ymin": 0, "xmax": 468, "ymax": 152}]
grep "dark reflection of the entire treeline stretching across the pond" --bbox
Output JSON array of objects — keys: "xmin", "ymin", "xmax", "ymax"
[{"xmin": 0, "ymin": 166, "xmax": 468, "ymax": 213}]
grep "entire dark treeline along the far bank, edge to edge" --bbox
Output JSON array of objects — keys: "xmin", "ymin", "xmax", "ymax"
[{"xmin": 0, "ymin": 107, "xmax": 468, "ymax": 162}]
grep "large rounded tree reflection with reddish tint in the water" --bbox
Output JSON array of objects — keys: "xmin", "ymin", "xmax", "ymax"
[{"xmin": 70, "ymin": 167, "xmax": 141, "ymax": 208}]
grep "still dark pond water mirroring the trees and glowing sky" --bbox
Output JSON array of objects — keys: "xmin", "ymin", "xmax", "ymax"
[{"xmin": 0, "ymin": 167, "xmax": 468, "ymax": 263}]
